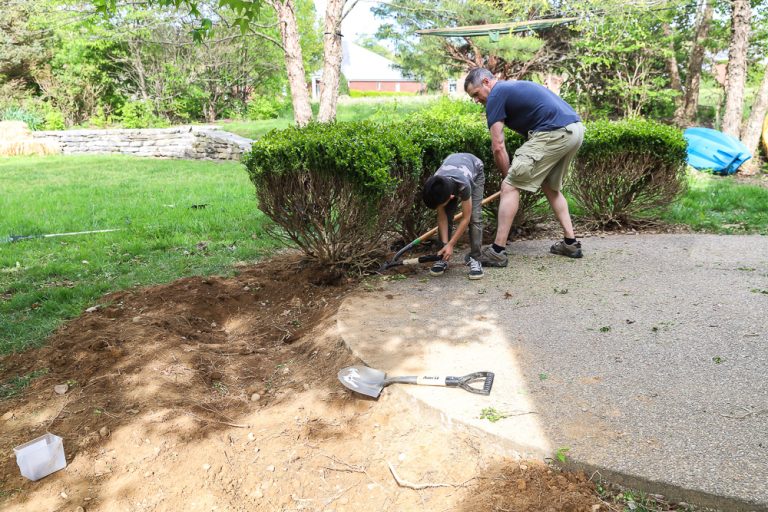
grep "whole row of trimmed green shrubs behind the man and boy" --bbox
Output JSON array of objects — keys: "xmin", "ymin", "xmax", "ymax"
[{"xmin": 244, "ymin": 117, "xmax": 686, "ymax": 265}]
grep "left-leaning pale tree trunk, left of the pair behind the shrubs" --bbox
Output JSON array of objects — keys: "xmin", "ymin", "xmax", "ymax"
[{"xmin": 269, "ymin": 0, "xmax": 312, "ymax": 126}]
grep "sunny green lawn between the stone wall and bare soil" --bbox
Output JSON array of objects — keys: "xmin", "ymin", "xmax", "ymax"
[{"xmin": 0, "ymin": 156, "xmax": 278, "ymax": 354}]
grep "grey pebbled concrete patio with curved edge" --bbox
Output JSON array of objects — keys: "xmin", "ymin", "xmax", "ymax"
[{"xmin": 338, "ymin": 235, "xmax": 768, "ymax": 511}]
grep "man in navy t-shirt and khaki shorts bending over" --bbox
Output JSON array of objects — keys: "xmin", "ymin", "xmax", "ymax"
[{"xmin": 464, "ymin": 68, "xmax": 584, "ymax": 267}]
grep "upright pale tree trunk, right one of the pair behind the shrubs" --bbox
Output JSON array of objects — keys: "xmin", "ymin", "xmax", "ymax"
[{"xmin": 317, "ymin": 0, "xmax": 346, "ymax": 123}]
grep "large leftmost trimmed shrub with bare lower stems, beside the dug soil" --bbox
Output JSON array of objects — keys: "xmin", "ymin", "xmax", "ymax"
[{"xmin": 244, "ymin": 121, "xmax": 421, "ymax": 267}]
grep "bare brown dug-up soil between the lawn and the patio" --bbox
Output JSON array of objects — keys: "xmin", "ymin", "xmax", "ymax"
[{"xmin": 0, "ymin": 258, "xmax": 609, "ymax": 512}]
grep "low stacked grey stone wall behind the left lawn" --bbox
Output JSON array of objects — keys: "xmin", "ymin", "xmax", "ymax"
[{"xmin": 33, "ymin": 126, "xmax": 253, "ymax": 160}]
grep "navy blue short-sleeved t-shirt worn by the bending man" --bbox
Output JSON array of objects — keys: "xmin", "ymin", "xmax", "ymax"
[{"xmin": 485, "ymin": 80, "xmax": 581, "ymax": 137}]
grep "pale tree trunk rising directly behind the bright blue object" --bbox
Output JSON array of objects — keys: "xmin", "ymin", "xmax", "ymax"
[{"xmin": 721, "ymin": 0, "xmax": 751, "ymax": 137}]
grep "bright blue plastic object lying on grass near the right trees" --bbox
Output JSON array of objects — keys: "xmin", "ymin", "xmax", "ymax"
[{"xmin": 683, "ymin": 128, "xmax": 752, "ymax": 174}]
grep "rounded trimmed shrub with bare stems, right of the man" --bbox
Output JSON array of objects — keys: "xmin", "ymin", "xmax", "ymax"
[{"xmin": 568, "ymin": 119, "xmax": 687, "ymax": 227}]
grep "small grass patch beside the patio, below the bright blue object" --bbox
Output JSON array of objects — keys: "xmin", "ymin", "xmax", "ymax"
[{"xmin": 664, "ymin": 170, "xmax": 768, "ymax": 235}]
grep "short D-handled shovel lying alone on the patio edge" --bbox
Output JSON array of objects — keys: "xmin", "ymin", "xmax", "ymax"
[{"xmin": 338, "ymin": 365, "xmax": 493, "ymax": 398}]
